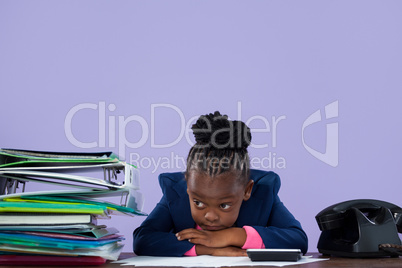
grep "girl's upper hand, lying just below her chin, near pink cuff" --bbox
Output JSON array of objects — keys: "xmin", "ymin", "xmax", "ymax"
[{"xmin": 176, "ymin": 227, "xmax": 247, "ymax": 248}]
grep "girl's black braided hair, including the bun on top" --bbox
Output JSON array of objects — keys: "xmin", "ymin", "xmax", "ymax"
[{"xmin": 186, "ymin": 111, "xmax": 251, "ymax": 182}]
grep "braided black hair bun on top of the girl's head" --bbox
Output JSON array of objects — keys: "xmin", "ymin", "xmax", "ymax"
[{"xmin": 191, "ymin": 111, "xmax": 251, "ymax": 149}]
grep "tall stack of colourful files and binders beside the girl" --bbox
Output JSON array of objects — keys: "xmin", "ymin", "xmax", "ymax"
[{"xmin": 0, "ymin": 149, "xmax": 145, "ymax": 265}]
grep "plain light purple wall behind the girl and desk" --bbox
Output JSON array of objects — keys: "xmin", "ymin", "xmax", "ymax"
[{"xmin": 0, "ymin": 0, "xmax": 402, "ymax": 252}]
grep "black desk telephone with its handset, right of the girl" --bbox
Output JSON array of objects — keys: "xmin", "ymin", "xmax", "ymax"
[{"xmin": 315, "ymin": 199, "xmax": 402, "ymax": 257}]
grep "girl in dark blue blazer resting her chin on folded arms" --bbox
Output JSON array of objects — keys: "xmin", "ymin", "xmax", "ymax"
[{"xmin": 134, "ymin": 112, "xmax": 307, "ymax": 256}]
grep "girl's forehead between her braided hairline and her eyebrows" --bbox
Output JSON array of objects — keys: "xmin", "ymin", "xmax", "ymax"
[{"xmin": 187, "ymin": 172, "xmax": 244, "ymax": 199}]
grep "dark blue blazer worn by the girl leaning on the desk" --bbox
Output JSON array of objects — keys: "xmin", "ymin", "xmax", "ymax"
[{"xmin": 134, "ymin": 170, "xmax": 307, "ymax": 256}]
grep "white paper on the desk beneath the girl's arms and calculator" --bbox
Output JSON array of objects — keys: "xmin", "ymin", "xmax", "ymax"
[{"xmin": 113, "ymin": 255, "xmax": 328, "ymax": 267}]
